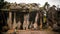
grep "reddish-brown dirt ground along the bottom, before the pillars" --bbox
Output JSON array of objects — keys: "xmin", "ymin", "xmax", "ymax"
[{"xmin": 4, "ymin": 30, "xmax": 59, "ymax": 34}]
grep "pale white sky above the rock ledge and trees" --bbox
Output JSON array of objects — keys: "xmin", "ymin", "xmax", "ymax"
[{"xmin": 5, "ymin": 0, "xmax": 60, "ymax": 7}]
